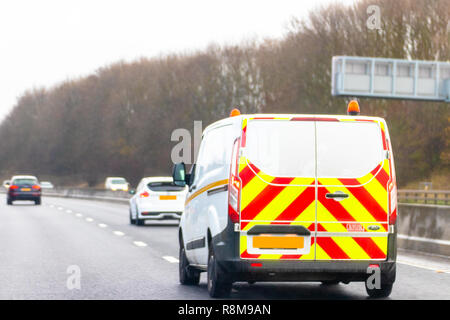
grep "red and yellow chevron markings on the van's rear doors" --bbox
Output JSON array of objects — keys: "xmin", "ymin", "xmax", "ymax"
[{"xmin": 239, "ymin": 159, "xmax": 389, "ymax": 260}]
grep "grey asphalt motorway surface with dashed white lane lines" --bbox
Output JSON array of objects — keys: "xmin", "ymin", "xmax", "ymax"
[{"xmin": 0, "ymin": 195, "xmax": 450, "ymax": 300}]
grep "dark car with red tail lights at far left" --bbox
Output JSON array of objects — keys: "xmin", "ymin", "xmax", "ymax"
[{"xmin": 6, "ymin": 176, "xmax": 41, "ymax": 205}]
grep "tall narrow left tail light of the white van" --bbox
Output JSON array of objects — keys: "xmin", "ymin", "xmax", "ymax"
[{"xmin": 228, "ymin": 139, "xmax": 242, "ymax": 223}]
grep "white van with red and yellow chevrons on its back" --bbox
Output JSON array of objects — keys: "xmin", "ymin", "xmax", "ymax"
[{"xmin": 173, "ymin": 105, "xmax": 397, "ymax": 297}]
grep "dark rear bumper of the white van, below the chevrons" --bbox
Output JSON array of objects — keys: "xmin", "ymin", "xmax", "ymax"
[{"xmin": 219, "ymin": 258, "xmax": 396, "ymax": 284}]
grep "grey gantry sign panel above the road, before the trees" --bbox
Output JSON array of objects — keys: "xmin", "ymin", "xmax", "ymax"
[{"xmin": 331, "ymin": 56, "xmax": 450, "ymax": 102}]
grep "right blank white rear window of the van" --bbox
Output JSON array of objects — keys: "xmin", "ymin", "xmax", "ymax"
[{"xmin": 316, "ymin": 121, "xmax": 384, "ymax": 178}]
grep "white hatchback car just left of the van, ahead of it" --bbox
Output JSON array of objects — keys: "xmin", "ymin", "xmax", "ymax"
[{"xmin": 130, "ymin": 177, "xmax": 187, "ymax": 226}]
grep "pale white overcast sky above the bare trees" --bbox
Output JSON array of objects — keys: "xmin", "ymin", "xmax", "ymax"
[{"xmin": 0, "ymin": 0, "xmax": 354, "ymax": 119}]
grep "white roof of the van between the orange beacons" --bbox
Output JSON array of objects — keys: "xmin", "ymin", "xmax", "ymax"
[{"xmin": 204, "ymin": 113, "xmax": 385, "ymax": 132}]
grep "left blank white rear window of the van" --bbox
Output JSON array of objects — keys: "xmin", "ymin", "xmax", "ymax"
[{"xmin": 246, "ymin": 120, "xmax": 315, "ymax": 177}]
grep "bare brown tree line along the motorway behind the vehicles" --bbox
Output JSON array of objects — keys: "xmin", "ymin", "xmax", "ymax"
[{"xmin": 0, "ymin": 0, "xmax": 450, "ymax": 187}]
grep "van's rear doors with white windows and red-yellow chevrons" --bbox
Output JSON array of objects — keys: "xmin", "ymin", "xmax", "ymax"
[{"xmin": 239, "ymin": 117, "xmax": 390, "ymax": 260}]
